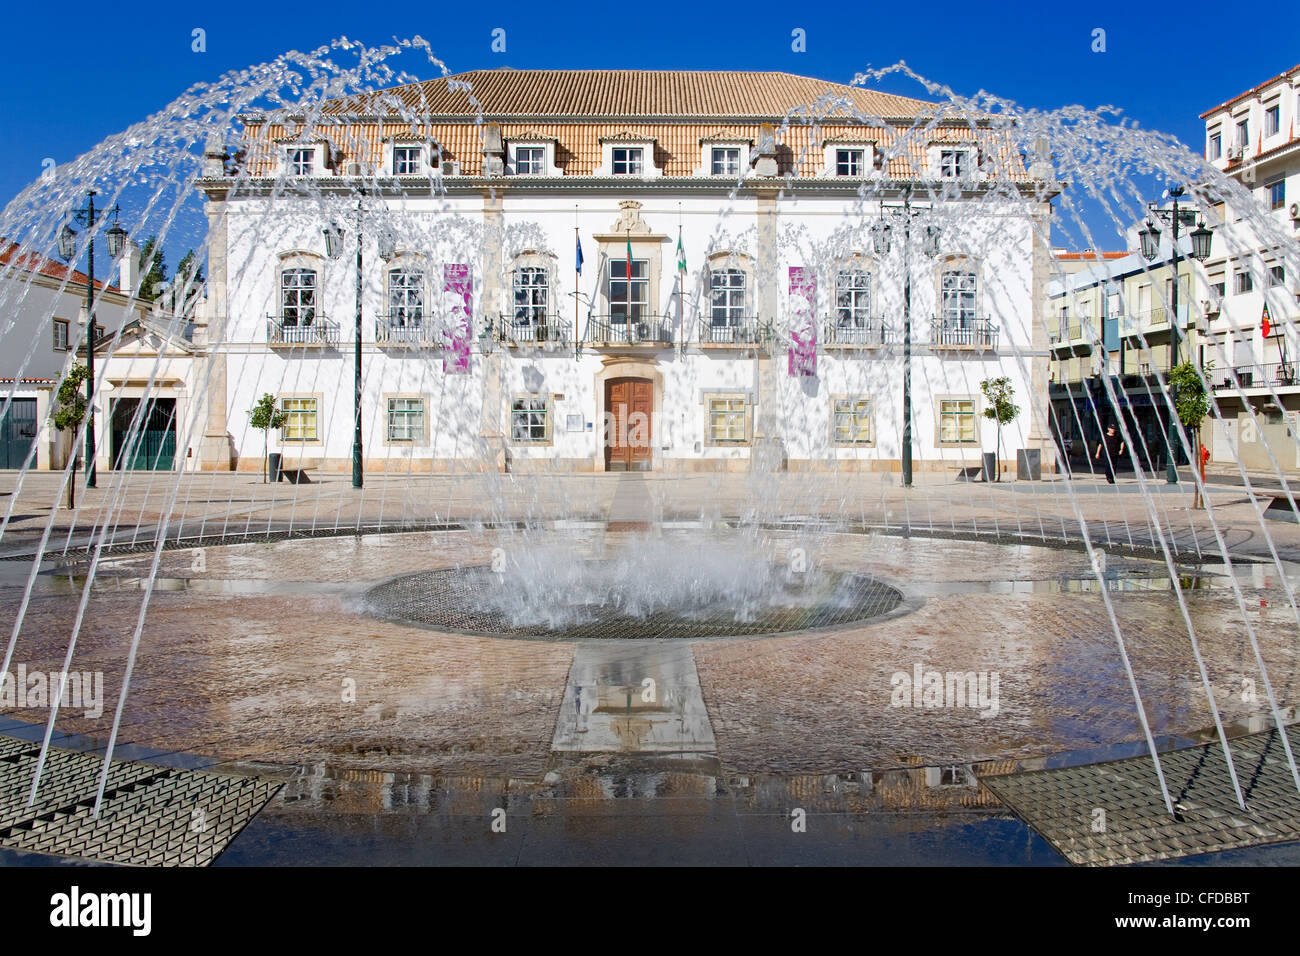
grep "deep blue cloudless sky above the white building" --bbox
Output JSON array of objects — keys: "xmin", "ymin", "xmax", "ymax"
[{"xmin": 0, "ymin": 0, "xmax": 1300, "ymax": 264}]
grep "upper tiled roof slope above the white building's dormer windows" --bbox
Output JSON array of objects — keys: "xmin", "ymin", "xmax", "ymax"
[{"xmin": 326, "ymin": 69, "xmax": 933, "ymax": 120}]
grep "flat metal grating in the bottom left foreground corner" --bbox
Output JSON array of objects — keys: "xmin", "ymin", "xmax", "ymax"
[{"xmin": 0, "ymin": 736, "xmax": 283, "ymax": 866}]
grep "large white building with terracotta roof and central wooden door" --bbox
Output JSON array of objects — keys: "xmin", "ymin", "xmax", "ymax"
[{"xmin": 196, "ymin": 69, "xmax": 1057, "ymax": 473}]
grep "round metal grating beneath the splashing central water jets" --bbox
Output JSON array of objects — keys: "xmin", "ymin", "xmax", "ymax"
[{"xmin": 365, "ymin": 567, "xmax": 902, "ymax": 640}]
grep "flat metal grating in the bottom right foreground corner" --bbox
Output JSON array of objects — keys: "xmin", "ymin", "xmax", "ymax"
[{"xmin": 980, "ymin": 730, "xmax": 1300, "ymax": 866}]
